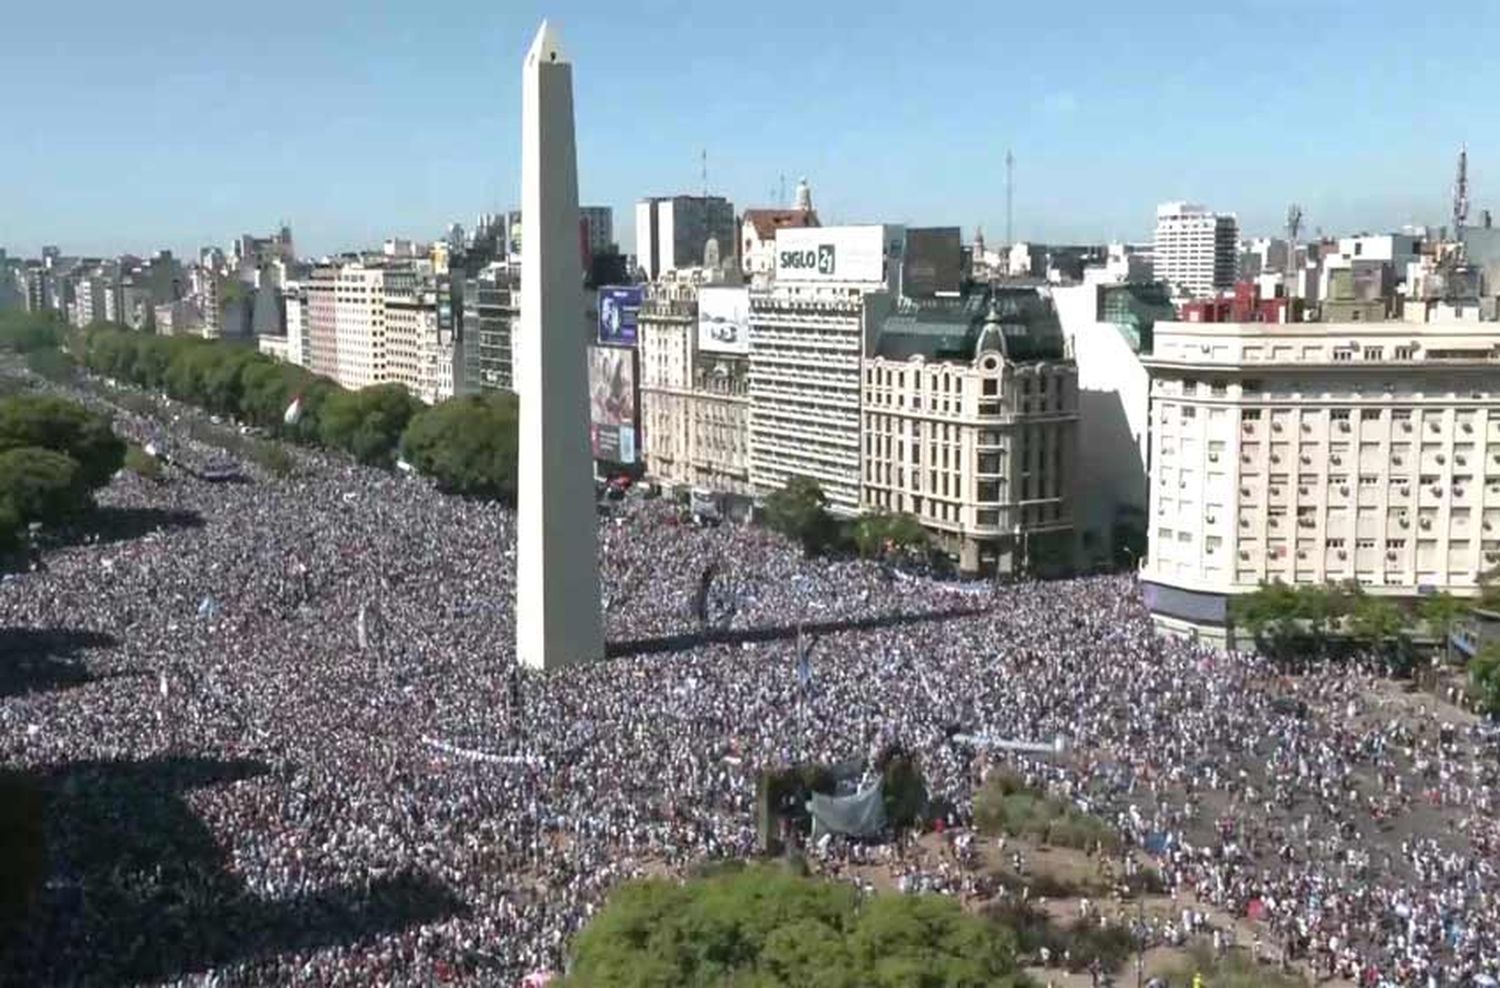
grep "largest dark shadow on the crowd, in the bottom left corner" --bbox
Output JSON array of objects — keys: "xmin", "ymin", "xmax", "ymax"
[{"xmin": 0, "ymin": 757, "xmax": 464, "ymax": 985}]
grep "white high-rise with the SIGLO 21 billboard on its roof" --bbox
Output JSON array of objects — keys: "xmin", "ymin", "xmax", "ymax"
[{"xmin": 749, "ymin": 225, "xmax": 905, "ymax": 514}]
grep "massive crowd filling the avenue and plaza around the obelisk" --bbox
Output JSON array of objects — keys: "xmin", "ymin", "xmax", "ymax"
[{"xmin": 0, "ymin": 389, "xmax": 1500, "ymax": 985}]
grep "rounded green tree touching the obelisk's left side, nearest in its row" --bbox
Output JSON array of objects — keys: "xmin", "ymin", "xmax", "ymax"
[{"xmin": 401, "ymin": 394, "xmax": 519, "ymax": 504}]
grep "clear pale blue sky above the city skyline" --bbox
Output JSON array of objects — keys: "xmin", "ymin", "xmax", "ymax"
[{"xmin": 0, "ymin": 0, "xmax": 1500, "ymax": 255}]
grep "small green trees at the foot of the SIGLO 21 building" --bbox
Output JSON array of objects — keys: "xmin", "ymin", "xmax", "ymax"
[{"xmin": 765, "ymin": 477, "xmax": 932, "ymax": 561}]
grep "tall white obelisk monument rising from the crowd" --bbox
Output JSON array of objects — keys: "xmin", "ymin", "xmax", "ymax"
[{"xmin": 516, "ymin": 22, "xmax": 605, "ymax": 669}]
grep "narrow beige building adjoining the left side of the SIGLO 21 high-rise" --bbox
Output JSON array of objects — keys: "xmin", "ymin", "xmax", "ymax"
[{"xmin": 638, "ymin": 270, "xmax": 750, "ymax": 495}]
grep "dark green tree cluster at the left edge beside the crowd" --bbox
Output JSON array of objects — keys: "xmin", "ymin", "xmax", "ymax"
[{"xmin": 0, "ymin": 394, "xmax": 125, "ymax": 549}]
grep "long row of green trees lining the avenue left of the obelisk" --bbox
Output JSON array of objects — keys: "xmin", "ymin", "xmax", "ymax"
[{"xmin": 69, "ymin": 327, "xmax": 518, "ymax": 501}]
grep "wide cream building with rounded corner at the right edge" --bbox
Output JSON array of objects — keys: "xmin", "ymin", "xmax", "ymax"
[{"xmin": 1142, "ymin": 322, "xmax": 1500, "ymax": 642}]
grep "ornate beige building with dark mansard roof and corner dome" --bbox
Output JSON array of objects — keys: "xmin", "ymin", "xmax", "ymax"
[{"xmin": 861, "ymin": 289, "xmax": 1079, "ymax": 576}]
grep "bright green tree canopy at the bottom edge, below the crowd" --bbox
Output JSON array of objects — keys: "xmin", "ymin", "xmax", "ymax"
[{"xmin": 564, "ymin": 865, "xmax": 1025, "ymax": 988}]
